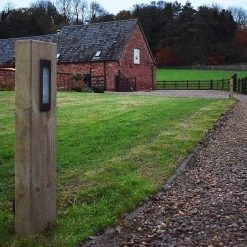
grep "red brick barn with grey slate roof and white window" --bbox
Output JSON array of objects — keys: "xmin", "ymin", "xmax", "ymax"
[{"xmin": 0, "ymin": 19, "xmax": 155, "ymax": 91}]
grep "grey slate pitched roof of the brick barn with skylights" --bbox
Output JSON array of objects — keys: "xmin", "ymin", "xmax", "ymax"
[{"xmin": 0, "ymin": 19, "xmax": 138, "ymax": 65}]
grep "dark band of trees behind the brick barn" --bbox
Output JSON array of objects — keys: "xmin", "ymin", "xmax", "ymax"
[{"xmin": 0, "ymin": 0, "xmax": 247, "ymax": 66}]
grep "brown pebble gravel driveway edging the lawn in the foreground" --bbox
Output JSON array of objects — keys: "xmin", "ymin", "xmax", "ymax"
[{"xmin": 80, "ymin": 99, "xmax": 247, "ymax": 247}]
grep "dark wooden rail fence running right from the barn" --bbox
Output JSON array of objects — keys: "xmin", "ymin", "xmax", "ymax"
[{"xmin": 156, "ymin": 79, "xmax": 230, "ymax": 90}]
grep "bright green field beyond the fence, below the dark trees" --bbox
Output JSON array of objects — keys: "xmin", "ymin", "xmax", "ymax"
[{"xmin": 157, "ymin": 68, "xmax": 247, "ymax": 81}]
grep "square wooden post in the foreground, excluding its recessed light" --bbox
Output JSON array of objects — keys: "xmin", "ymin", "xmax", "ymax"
[{"xmin": 15, "ymin": 40, "xmax": 56, "ymax": 235}]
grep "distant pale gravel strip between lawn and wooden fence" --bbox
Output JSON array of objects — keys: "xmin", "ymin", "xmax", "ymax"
[{"xmin": 107, "ymin": 90, "xmax": 247, "ymax": 101}]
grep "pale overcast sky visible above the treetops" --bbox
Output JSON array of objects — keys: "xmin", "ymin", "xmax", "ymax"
[{"xmin": 0, "ymin": 0, "xmax": 247, "ymax": 14}]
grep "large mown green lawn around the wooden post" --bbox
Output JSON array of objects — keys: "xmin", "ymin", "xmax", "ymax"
[{"xmin": 0, "ymin": 92, "xmax": 233, "ymax": 247}]
